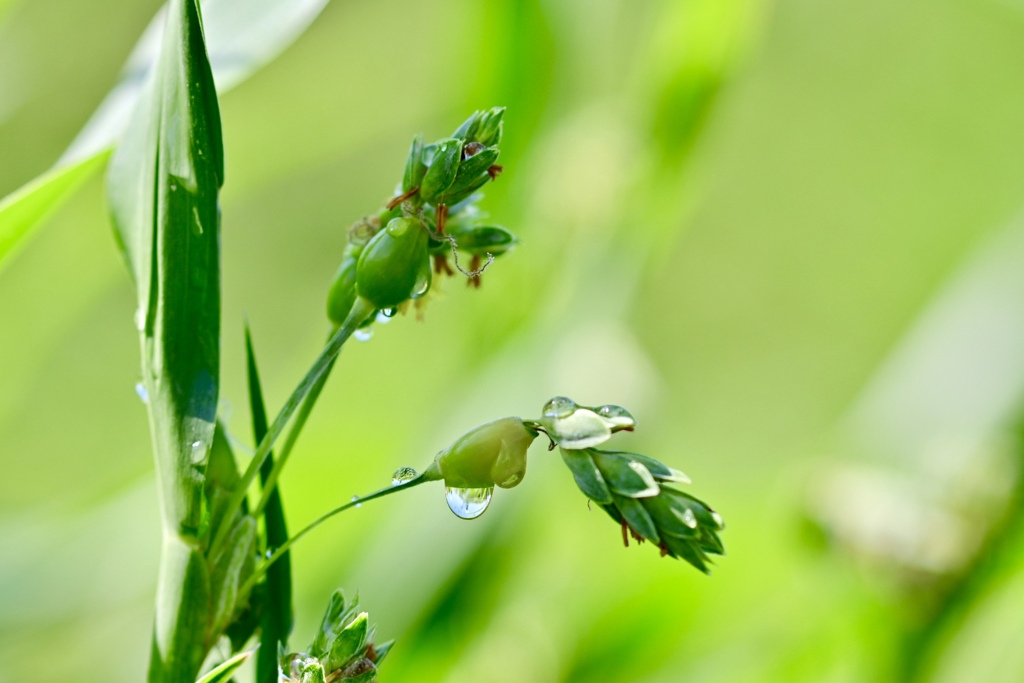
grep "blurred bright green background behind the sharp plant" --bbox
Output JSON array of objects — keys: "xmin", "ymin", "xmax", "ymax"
[{"xmin": 0, "ymin": 0, "xmax": 1024, "ymax": 683}]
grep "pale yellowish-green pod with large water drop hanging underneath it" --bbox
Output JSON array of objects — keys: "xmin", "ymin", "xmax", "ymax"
[{"xmin": 430, "ymin": 418, "xmax": 538, "ymax": 488}]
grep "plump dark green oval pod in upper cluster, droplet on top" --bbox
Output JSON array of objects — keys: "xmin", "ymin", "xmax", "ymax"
[{"xmin": 355, "ymin": 218, "xmax": 430, "ymax": 309}]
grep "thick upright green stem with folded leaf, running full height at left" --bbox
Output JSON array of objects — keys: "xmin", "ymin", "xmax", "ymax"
[{"xmin": 108, "ymin": 0, "xmax": 221, "ymax": 683}]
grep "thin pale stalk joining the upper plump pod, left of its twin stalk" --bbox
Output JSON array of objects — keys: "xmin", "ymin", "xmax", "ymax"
[{"xmin": 209, "ymin": 298, "xmax": 375, "ymax": 557}]
